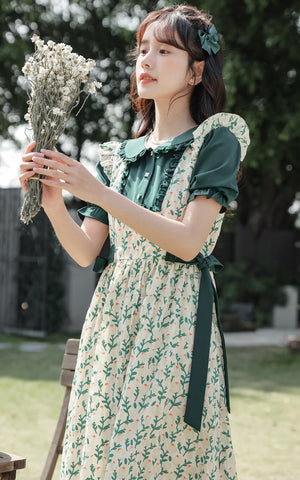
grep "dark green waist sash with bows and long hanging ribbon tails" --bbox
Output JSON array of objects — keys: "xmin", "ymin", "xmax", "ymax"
[{"xmin": 94, "ymin": 246, "xmax": 230, "ymax": 431}]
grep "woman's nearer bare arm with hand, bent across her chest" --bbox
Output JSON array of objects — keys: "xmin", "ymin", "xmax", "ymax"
[{"xmin": 33, "ymin": 150, "xmax": 220, "ymax": 261}]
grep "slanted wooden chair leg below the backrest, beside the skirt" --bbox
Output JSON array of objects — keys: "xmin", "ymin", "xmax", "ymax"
[{"xmin": 41, "ymin": 387, "xmax": 71, "ymax": 480}]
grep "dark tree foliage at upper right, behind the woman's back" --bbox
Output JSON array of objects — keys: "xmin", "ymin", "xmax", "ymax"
[{"xmin": 199, "ymin": 0, "xmax": 300, "ymax": 233}]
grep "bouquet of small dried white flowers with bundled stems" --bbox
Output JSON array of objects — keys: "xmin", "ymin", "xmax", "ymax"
[{"xmin": 21, "ymin": 35, "xmax": 101, "ymax": 224}]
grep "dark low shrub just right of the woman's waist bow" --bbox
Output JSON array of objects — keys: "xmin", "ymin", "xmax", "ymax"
[{"xmin": 216, "ymin": 261, "xmax": 286, "ymax": 327}]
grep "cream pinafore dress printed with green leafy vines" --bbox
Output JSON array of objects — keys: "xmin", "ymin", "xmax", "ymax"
[{"xmin": 61, "ymin": 113, "xmax": 249, "ymax": 480}]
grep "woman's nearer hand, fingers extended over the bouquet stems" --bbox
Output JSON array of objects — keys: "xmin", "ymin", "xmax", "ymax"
[{"xmin": 31, "ymin": 150, "xmax": 105, "ymax": 203}]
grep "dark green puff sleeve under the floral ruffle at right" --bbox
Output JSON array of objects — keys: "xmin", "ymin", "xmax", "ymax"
[{"xmin": 189, "ymin": 127, "xmax": 241, "ymax": 213}]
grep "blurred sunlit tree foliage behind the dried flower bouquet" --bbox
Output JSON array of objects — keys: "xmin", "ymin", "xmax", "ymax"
[{"xmin": 0, "ymin": 0, "xmax": 145, "ymax": 152}]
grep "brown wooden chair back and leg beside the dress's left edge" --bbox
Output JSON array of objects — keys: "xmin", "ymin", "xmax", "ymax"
[{"xmin": 40, "ymin": 338, "xmax": 79, "ymax": 480}]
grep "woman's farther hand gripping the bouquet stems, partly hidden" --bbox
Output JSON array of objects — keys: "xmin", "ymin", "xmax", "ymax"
[{"xmin": 19, "ymin": 142, "xmax": 63, "ymax": 212}]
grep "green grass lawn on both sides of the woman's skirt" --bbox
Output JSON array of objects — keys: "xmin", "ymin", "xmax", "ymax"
[{"xmin": 0, "ymin": 335, "xmax": 300, "ymax": 480}]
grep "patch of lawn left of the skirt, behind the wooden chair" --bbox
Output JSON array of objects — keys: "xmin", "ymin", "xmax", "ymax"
[{"xmin": 0, "ymin": 339, "xmax": 64, "ymax": 480}]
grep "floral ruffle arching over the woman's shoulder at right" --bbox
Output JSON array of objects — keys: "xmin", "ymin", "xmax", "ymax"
[{"xmin": 194, "ymin": 112, "xmax": 250, "ymax": 162}]
